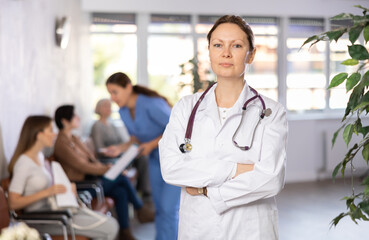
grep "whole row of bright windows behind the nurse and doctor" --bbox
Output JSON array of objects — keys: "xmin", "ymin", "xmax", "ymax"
[{"xmin": 87, "ymin": 13, "xmax": 360, "ymax": 116}]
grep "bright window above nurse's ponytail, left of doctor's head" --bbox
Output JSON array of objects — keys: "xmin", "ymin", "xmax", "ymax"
[{"xmin": 147, "ymin": 14, "xmax": 194, "ymax": 104}]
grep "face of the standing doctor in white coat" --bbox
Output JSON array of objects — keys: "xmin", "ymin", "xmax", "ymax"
[{"xmin": 209, "ymin": 23, "xmax": 255, "ymax": 79}]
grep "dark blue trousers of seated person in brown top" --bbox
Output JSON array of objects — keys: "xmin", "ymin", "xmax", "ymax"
[{"xmin": 102, "ymin": 175, "xmax": 143, "ymax": 229}]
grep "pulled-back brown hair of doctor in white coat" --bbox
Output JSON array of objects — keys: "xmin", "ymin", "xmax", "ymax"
[{"xmin": 207, "ymin": 15, "xmax": 255, "ymax": 51}]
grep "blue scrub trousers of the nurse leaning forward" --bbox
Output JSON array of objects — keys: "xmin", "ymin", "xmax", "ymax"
[{"xmin": 149, "ymin": 158, "xmax": 181, "ymax": 240}]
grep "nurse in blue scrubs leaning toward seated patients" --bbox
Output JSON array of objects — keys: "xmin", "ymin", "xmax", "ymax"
[{"xmin": 106, "ymin": 72, "xmax": 180, "ymax": 240}]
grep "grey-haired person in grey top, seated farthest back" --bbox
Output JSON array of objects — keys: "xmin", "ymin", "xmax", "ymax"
[{"xmin": 90, "ymin": 98, "xmax": 151, "ymax": 201}]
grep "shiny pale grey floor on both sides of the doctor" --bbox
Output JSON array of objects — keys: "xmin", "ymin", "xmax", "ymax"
[{"xmin": 132, "ymin": 180, "xmax": 369, "ymax": 240}]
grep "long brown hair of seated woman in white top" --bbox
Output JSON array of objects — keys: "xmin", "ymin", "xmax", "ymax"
[{"xmin": 8, "ymin": 116, "xmax": 52, "ymax": 176}]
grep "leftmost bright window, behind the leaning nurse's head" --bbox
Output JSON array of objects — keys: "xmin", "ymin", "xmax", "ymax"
[{"xmin": 90, "ymin": 13, "xmax": 137, "ymax": 118}]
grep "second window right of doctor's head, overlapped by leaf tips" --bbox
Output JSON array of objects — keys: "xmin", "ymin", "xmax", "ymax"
[{"xmin": 286, "ymin": 18, "xmax": 327, "ymax": 111}]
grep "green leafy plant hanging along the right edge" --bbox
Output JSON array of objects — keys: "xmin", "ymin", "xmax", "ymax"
[{"xmin": 301, "ymin": 5, "xmax": 369, "ymax": 226}]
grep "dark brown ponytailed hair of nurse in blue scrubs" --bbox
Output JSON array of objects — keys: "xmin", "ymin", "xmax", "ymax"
[{"xmin": 106, "ymin": 72, "xmax": 170, "ymax": 105}]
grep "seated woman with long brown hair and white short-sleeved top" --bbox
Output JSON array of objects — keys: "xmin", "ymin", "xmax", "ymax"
[{"xmin": 8, "ymin": 116, "xmax": 118, "ymax": 239}]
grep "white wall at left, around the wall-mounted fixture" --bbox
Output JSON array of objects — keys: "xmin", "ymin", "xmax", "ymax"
[{"xmin": 0, "ymin": 0, "xmax": 93, "ymax": 162}]
